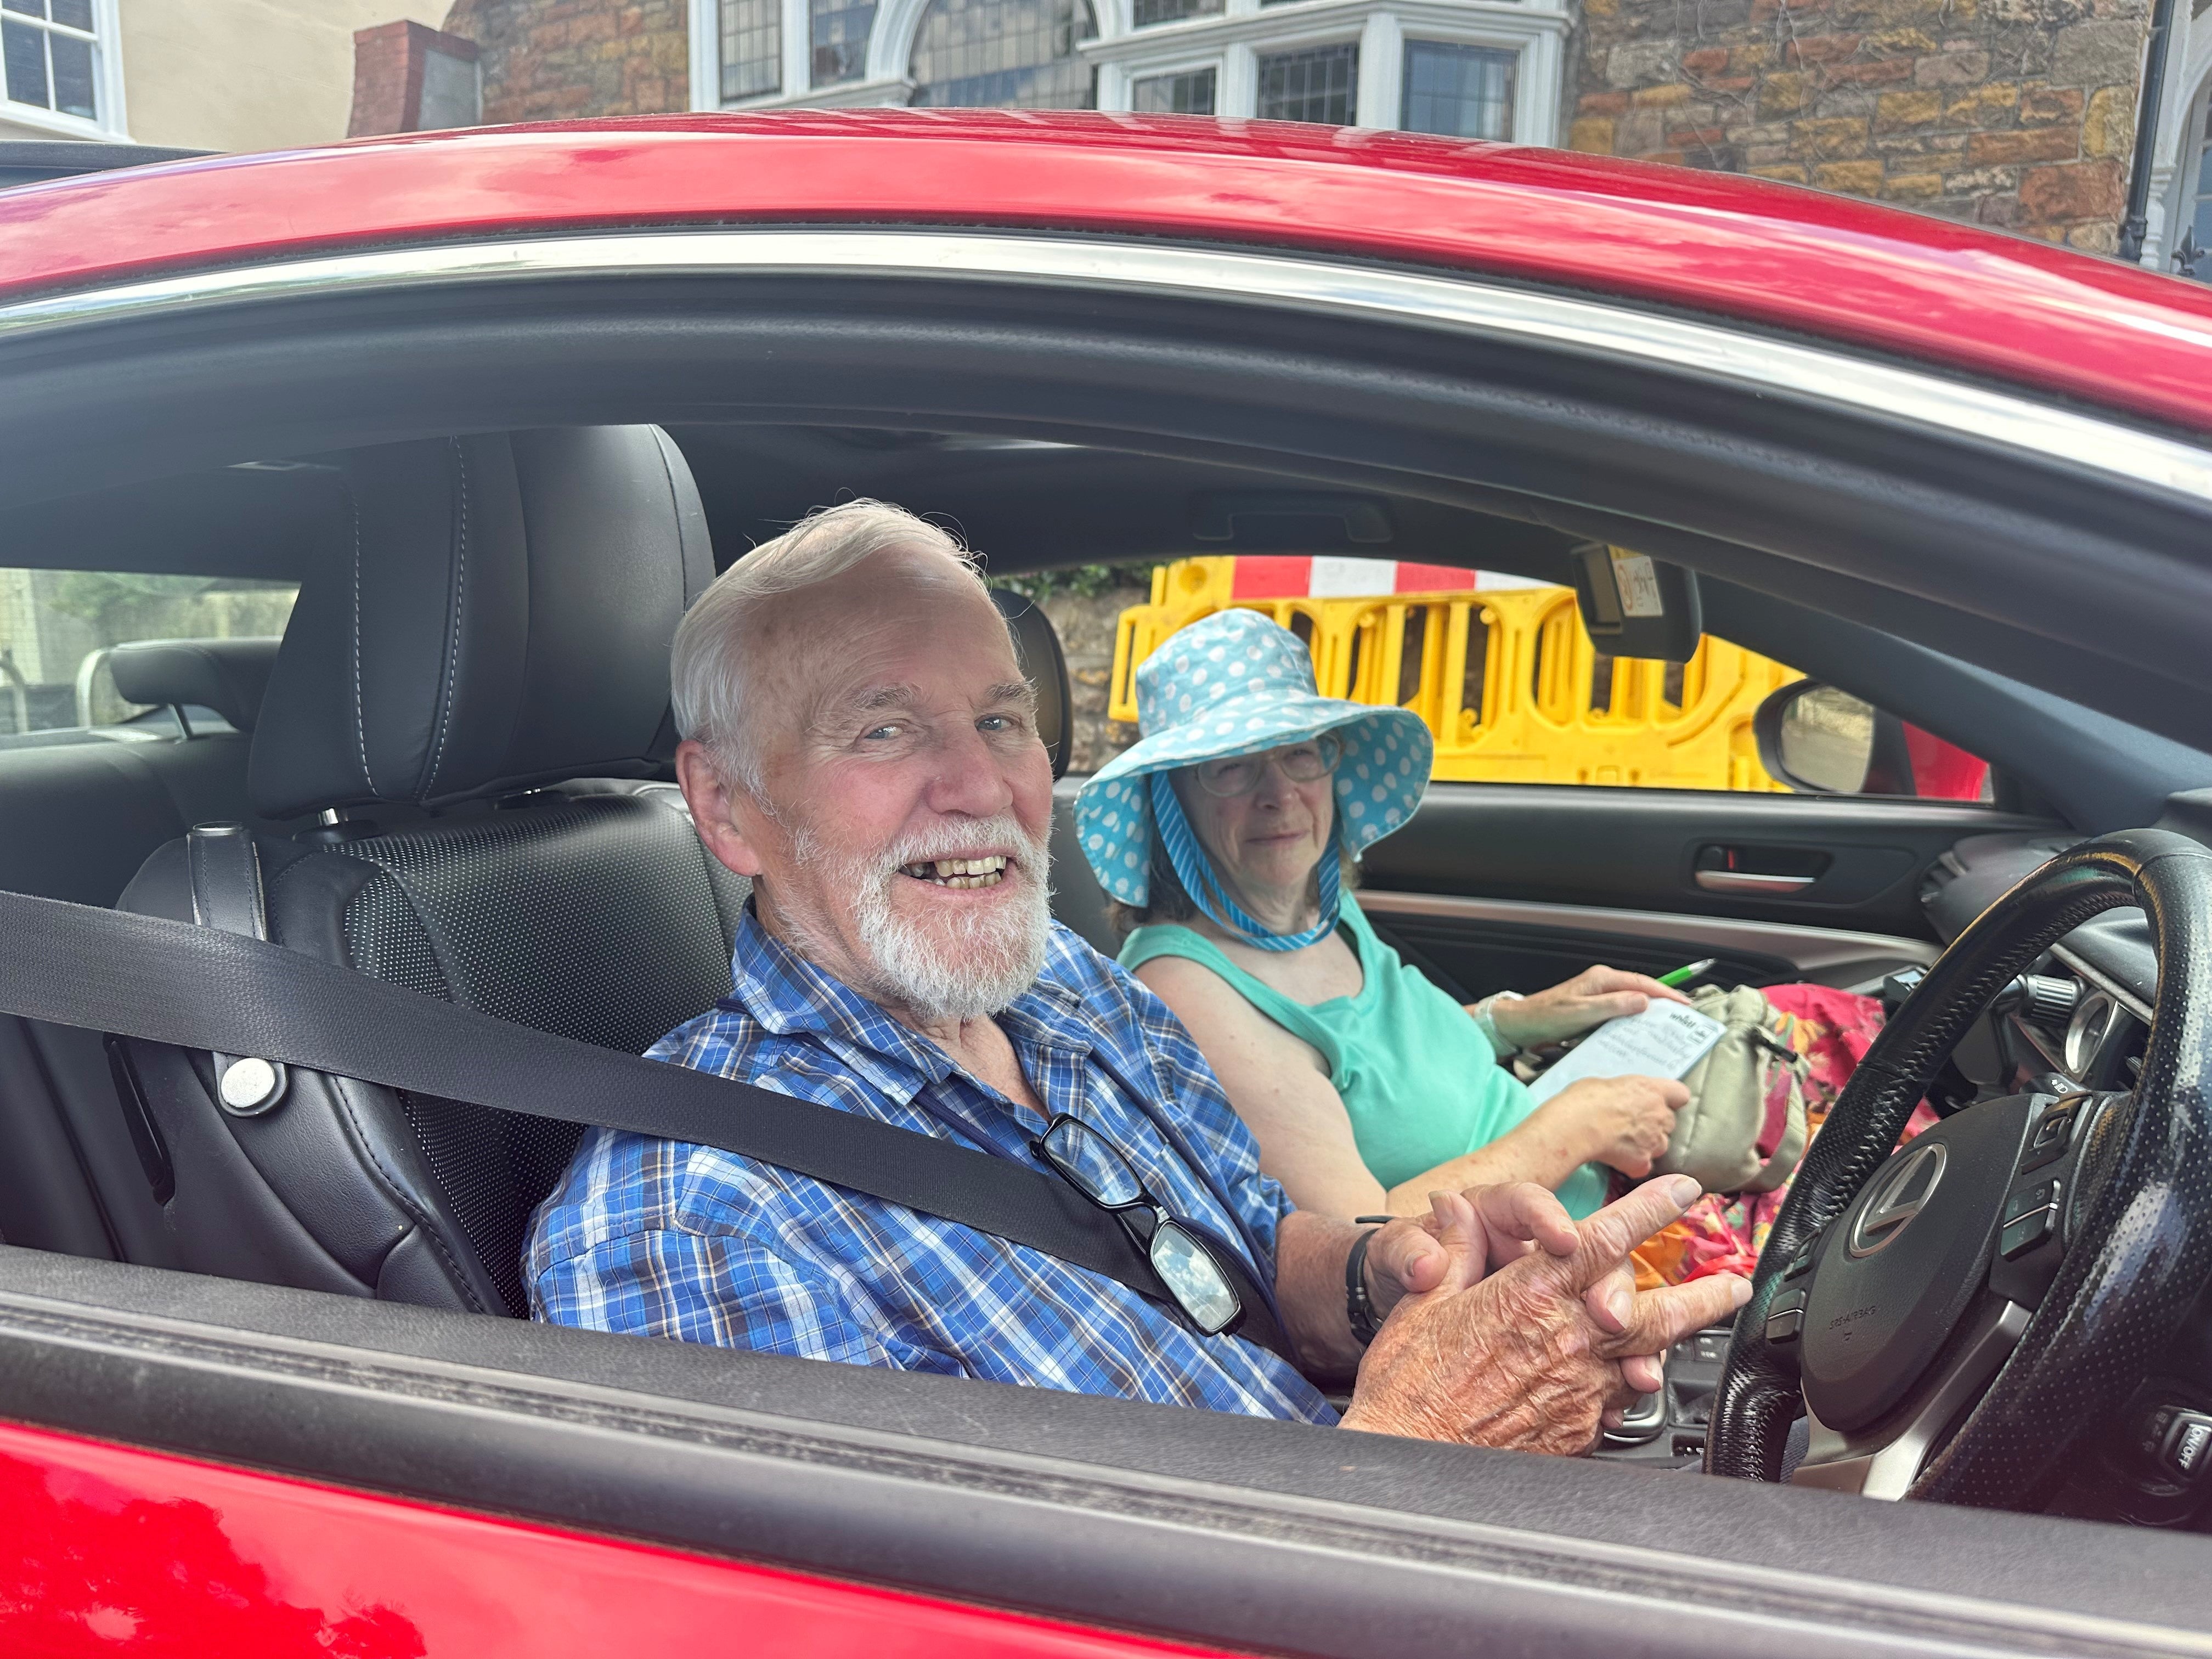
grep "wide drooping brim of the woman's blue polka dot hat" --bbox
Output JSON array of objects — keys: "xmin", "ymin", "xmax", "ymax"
[{"xmin": 1075, "ymin": 692, "xmax": 1436, "ymax": 905}]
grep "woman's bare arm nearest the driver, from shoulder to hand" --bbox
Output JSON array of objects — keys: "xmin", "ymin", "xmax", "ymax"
[{"xmin": 1137, "ymin": 956, "xmax": 1654, "ymax": 1221}]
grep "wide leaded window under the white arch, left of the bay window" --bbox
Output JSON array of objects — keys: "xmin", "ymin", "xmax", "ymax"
[{"xmin": 913, "ymin": 0, "xmax": 1099, "ymax": 109}]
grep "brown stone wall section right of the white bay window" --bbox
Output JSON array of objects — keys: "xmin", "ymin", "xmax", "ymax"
[{"xmin": 1568, "ymin": 0, "xmax": 2148, "ymax": 252}]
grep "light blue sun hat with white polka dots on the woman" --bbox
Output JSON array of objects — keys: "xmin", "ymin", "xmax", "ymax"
[{"xmin": 1075, "ymin": 611, "xmax": 1436, "ymax": 931}]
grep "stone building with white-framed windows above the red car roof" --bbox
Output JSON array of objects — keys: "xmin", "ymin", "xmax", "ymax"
[{"xmin": 380, "ymin": 0, "xmax": 2212, "ymax": 279}]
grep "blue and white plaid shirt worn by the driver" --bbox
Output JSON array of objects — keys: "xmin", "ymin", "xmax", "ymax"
[{"xmin": 524, "ymin": 909, "xmax": 1334, "ymax": 1423}]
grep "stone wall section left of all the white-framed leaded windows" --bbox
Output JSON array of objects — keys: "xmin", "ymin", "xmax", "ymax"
[{"xmin": 444, "ymin": 0, "xmax": 690, "ymax": 124}]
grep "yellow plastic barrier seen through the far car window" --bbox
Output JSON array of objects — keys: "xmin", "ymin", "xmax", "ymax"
[{"xmin": 1106, "ymin": 557, "xmax": 1798, "ymax": 794}]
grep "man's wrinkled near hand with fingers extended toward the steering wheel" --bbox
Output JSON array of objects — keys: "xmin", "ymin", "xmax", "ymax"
[{"xmin": 1342, "ymin": 1175, "xmax": 1752, "ymax": 1455}]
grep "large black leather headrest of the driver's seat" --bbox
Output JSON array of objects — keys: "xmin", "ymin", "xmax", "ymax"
[{"xmin": 248, "ymin": 427, "xmax": 714, "ymax": 819}]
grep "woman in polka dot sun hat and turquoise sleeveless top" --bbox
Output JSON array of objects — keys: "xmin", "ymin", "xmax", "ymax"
[{"xmin": 1075, "ymin": 611, "xmax": 1688, "ymax": 1219}]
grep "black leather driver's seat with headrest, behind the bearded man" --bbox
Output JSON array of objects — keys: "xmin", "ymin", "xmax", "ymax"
[{"xmin": 124, "ymin": 427, "xmax": 1066, "ymax": 1314}]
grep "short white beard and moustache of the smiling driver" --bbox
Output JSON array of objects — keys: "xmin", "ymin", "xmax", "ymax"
[{"xmin": 787, "ymin": 814, "xmax": 1053, "ymax": 1024}]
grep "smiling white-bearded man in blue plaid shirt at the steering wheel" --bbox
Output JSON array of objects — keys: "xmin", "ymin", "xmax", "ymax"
[{"xmin": 527, "ymin": 502, "xmax": 1750, "ymax": 1453}]
